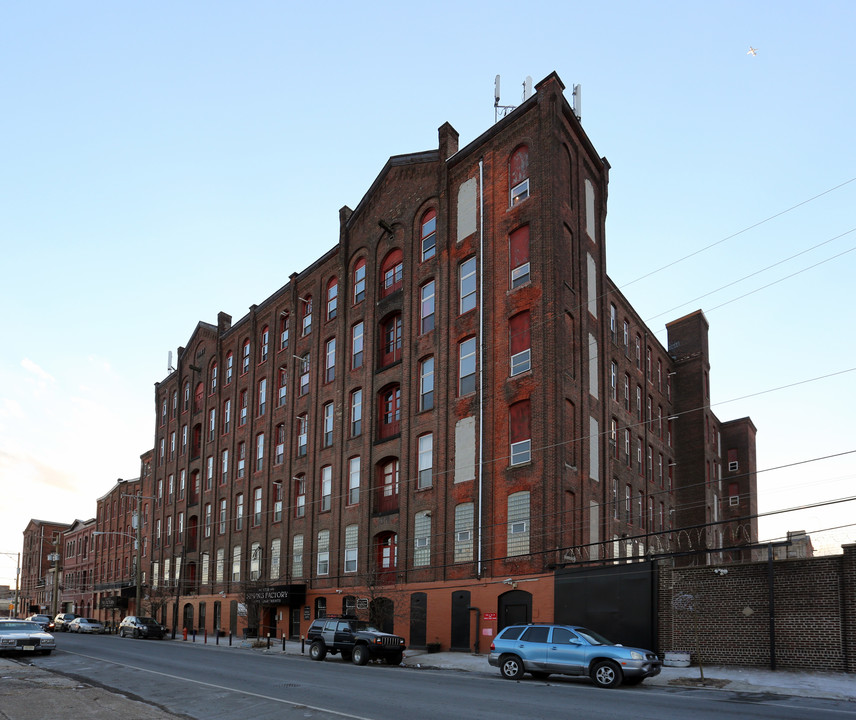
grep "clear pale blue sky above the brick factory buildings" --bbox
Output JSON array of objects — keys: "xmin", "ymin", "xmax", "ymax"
[{"xmin": 0, "ymin": 0, "xmax": 856, "ymax": 584}]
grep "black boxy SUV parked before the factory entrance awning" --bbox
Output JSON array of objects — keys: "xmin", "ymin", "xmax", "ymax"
[{"xmin": 306, "ymin": 615, "xmax": 405, "ymax": 665}]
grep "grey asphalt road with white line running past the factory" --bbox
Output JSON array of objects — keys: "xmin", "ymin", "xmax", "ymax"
[{"xmin": 33, "ymin": 633, "xmax": 856, "ymax": 720}]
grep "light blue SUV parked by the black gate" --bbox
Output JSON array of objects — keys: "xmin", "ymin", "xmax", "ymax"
[{"xmin": 487, "ymin": 625, "xmax": 662, "ymax": 688}]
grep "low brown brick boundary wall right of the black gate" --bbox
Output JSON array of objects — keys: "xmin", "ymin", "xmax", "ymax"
[{"xmin": 658, "ymin": 544, "xmax": 856, "ymax": 672}]
